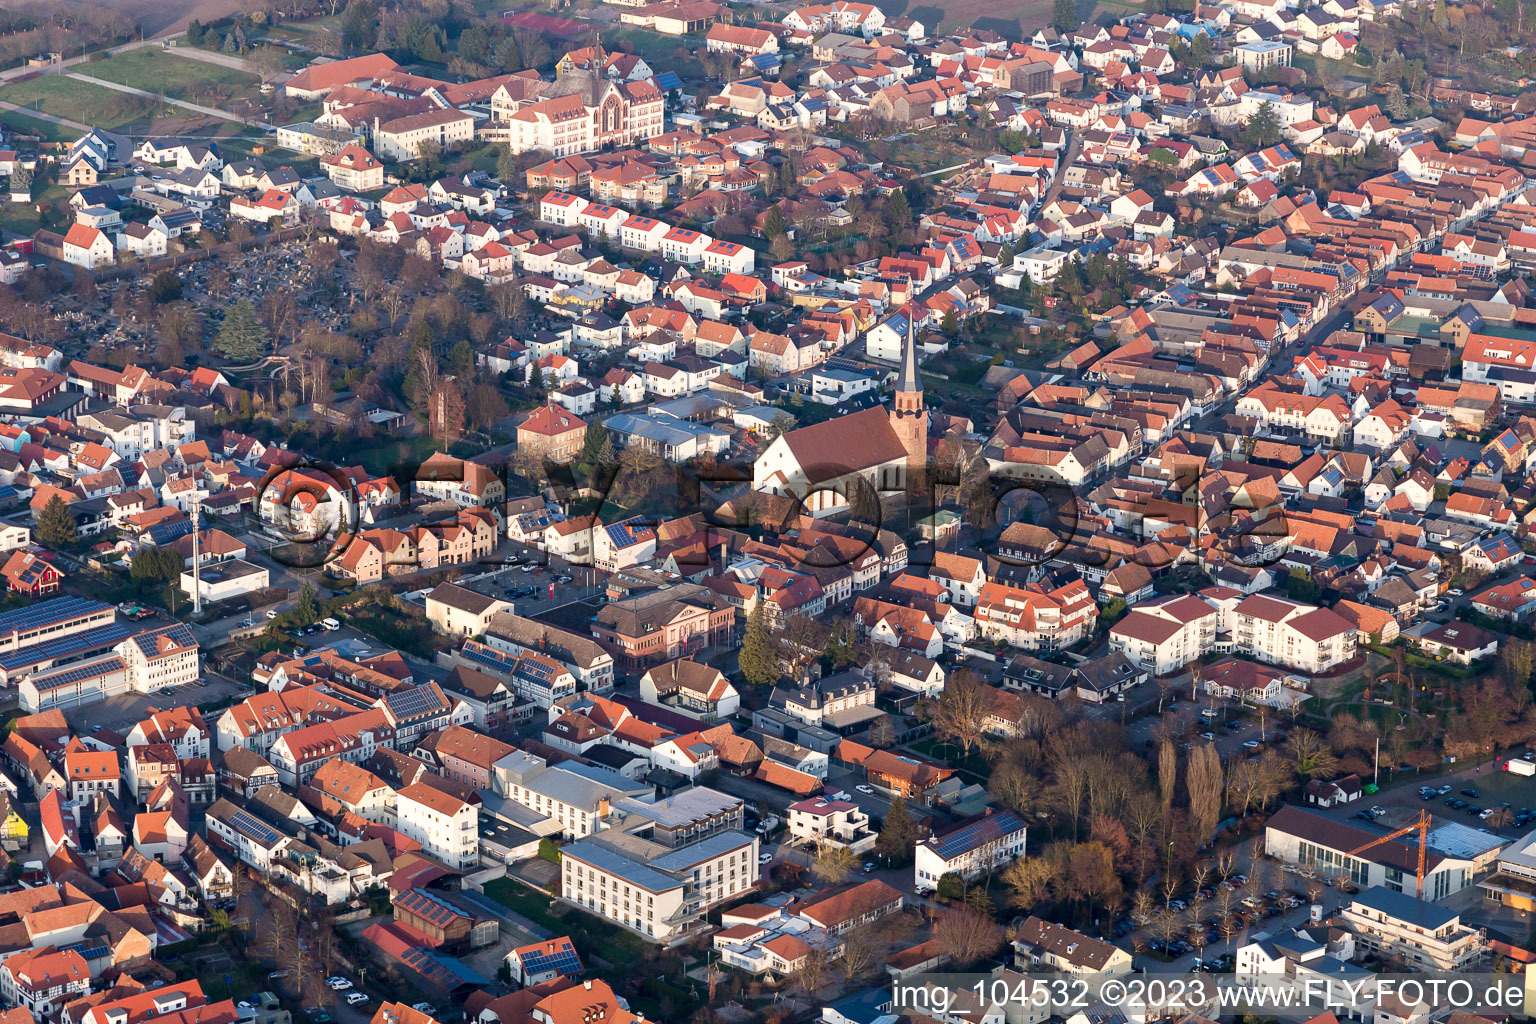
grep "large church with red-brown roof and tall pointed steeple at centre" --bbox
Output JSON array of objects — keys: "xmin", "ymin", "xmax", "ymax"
[{"xmin": 753, "ymin": 310, "xmax": 928, "ymax": 516}]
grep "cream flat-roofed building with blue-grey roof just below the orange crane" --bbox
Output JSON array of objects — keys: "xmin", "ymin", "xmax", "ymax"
[{"xmin": 1339, "ymin": 886, "xmax": 1488, "ymax": 970}]
